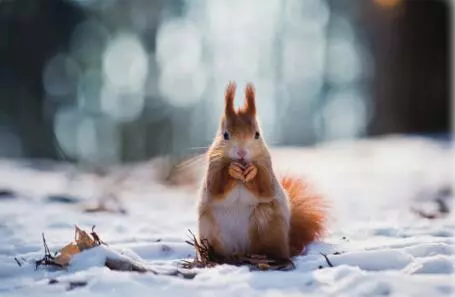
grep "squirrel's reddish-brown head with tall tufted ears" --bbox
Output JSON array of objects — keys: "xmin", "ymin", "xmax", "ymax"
[{"xmin": 213, "ymin": 82, "xmax": 268, "ymax": 163}]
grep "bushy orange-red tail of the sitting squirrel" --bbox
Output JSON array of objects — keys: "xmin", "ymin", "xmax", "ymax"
[{"xmin": 281, "ymin": 176, "xmax": 327, "ymax": 256}]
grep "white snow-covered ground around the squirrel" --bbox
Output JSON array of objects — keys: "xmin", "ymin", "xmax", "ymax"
[{"xmin": 0, "ymin": 137, "xmax": 455, "ymax": 297}]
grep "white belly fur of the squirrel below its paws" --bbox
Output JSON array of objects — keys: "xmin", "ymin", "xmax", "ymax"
[{"xmin": 214, "ymin": 185, "xmax": 258, "ymax": 254}]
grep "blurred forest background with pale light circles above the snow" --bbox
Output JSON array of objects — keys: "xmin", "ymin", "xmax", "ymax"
[{"xmin": 0, "ymin": 0, "xmax": 451, "ymax": 164}]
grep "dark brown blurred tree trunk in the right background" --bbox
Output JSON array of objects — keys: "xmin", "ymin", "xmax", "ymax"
[{"xmin": 357, "ymin": 0, "xmax": 451, "ymax": 135}]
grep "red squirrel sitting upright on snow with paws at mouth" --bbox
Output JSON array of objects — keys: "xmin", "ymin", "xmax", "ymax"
[{"xmin": 197, "ymin": 82, "xmax": 327, "ymax": 259}]
